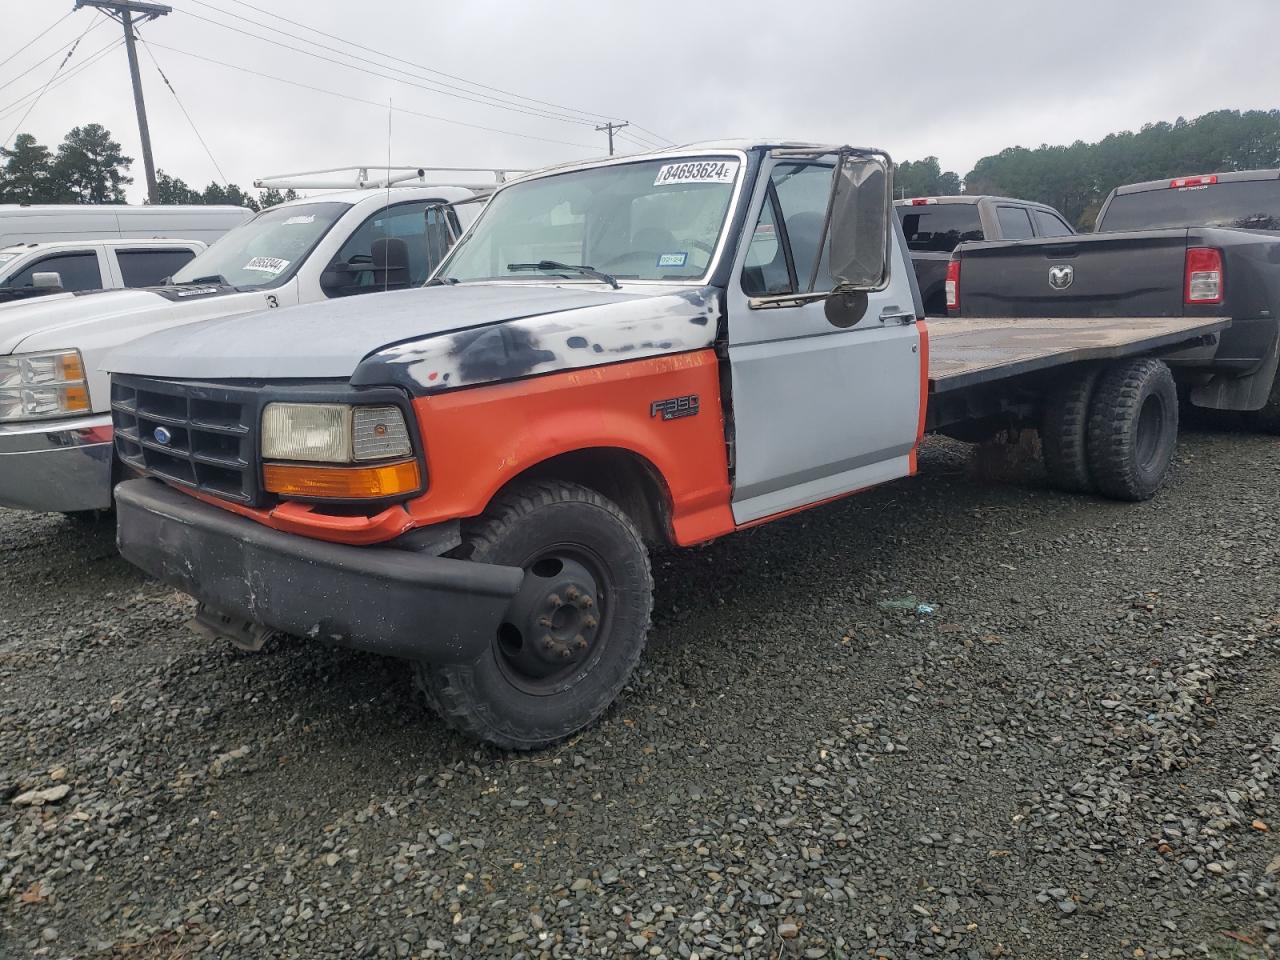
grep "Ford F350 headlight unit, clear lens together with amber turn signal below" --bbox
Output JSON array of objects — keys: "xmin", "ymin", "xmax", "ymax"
[{"xmin": 261, "ymin": 403, "xmax": 421, "ymax": 499}]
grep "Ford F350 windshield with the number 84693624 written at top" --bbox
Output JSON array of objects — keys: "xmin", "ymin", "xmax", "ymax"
[{"xmin": 436, "ymin": 156, "xmax": 741, "ymax": 283}]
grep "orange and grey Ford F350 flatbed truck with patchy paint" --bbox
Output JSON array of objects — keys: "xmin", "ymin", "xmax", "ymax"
[{"xmin": 108, "ymin": 141, "xmax": 1230, "ymax": 749}]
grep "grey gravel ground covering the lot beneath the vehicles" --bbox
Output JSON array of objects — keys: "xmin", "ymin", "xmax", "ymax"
[{"xmin": 0, "ymin": 428, "xmax": 1280, "ymax": 960}]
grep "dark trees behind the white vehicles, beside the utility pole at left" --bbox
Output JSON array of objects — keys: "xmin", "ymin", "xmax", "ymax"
[{"xmin": 0, "ymin": 123, "xmax": 298, "ymax": 210}]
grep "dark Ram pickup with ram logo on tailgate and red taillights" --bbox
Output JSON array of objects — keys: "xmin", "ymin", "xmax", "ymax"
[{"xmin": 947, "ymin": 170, "xmax": 1280, "ymax": 433}]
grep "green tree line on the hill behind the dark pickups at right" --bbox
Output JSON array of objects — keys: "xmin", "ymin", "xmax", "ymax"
[{"xmin": 895, "ymin": 110, "xmax": 1280, "ymax": 230}]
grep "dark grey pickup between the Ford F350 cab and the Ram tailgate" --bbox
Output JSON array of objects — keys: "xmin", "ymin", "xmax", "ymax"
[{"xmin": 893, "ymin": 195, "xmax": 1075, "ymax": 316}]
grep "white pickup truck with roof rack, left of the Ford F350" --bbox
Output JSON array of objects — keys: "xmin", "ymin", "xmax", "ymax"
[{"xmin": 0, "ymin": 170, "xmax": 495, "ymax": 513}]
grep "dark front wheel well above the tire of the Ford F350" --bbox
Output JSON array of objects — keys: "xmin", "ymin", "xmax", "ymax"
[{"xmin": 503, "ymin": 447, "xmax": 675, "ymax": 545}]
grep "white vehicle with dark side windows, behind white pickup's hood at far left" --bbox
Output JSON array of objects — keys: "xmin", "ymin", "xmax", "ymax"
[{"xmin": 0, "ymin": 239, "xmax": 206, "ymax": 305}]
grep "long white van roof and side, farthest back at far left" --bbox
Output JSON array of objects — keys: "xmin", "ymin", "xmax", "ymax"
[{"xmin": 0, "ymin": 204, "xmax": 253, "ymax": 247}]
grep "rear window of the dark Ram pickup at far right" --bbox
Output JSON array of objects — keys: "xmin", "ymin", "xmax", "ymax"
[{"xmin": 1098, "ymin": 179, "xmax": 1280, "ymax": 232}]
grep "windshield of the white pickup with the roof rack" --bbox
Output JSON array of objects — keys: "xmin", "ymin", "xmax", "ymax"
[{"xmin": 173, "ymin": 202, "xmax": 351, "ymax": 287}]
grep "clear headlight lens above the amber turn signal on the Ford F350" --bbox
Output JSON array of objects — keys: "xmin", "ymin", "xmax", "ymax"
[{"xmin": 262, "ymin": 403, "xmax": 413, "ymax": 463}]
